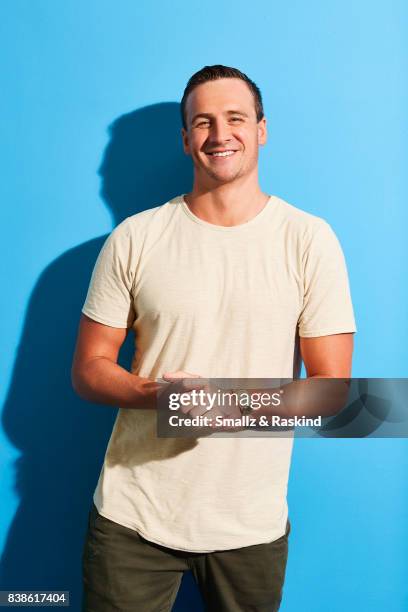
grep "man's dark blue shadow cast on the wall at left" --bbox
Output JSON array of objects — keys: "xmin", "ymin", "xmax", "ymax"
[{"xmin": 0, "ymin": 103, "xmax": 201, "ymax": 612}]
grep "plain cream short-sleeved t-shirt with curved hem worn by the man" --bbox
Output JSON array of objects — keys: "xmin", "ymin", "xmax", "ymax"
[{"xmin": 82, "ymin": 196, "xmax": 356, "ymax": 552}]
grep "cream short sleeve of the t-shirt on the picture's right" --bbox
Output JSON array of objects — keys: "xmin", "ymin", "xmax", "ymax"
[{"xmin": 298, "ymin": 220, "xmax": 356, "ymax": 338}]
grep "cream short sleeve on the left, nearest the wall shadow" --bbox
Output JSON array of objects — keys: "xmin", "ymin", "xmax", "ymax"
[{"xmin": 82, "ymin": 221, "xmax": 135, "ymax": 328}]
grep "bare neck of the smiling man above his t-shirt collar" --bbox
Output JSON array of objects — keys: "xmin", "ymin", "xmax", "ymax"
[{"xmin": 185, "ymin": 175, "xmax": 269, "ymax": 227}]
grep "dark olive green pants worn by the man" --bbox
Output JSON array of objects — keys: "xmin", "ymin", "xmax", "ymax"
[{"xmin": 82, "ymin": 504, "xmax": 290, "ymax": 612}]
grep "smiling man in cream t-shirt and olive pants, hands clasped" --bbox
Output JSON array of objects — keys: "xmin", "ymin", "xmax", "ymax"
[{"xmin": 73, "ymin": 66, "xmax": 355, "ymax": 612}]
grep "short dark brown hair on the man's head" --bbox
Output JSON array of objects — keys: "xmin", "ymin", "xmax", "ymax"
[{"xmin": 180, "ymin": 64, "xmax": 264, "ymax": 129}]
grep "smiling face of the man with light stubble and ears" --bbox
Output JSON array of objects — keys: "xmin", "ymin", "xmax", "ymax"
[{"xmin": 182, "ymin": 78, "xmax": 266, "ymax": 187}]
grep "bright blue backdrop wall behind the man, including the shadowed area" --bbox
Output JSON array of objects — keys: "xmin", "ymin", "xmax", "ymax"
[{"xmin": 0, "ymin": 0, "xmax": 408, "ymax": 612}]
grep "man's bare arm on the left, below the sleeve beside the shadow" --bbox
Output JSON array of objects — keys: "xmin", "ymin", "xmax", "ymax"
[{"xmin": 72, "ymin": 315, "xmax": 163, "ymax": 409}]
